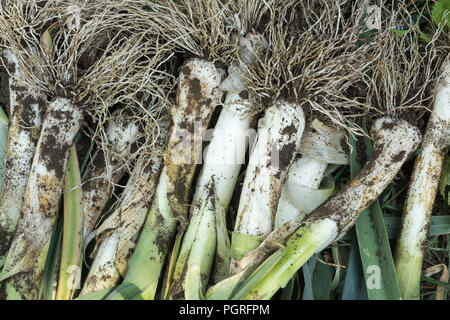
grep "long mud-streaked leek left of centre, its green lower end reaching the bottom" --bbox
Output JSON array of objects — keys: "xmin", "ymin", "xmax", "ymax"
[{"xmin": 105, "ymin": 58, "xmax": 223, "ymax": 300}]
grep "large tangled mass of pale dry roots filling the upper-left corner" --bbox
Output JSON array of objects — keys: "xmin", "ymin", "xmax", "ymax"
[{"xmin": 0, "ymin": 0, "xmax": 174, "ymax": 180}]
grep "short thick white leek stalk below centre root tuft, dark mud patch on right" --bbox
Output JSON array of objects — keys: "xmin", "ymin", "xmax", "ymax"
[{"xmin": 231, "ymin": 101, "xmax": 305, "ymax": 274}]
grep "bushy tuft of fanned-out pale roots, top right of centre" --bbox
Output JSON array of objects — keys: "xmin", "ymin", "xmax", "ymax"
[{"xmin": 239, "ymin": 0, "xmax": 375, "ymax": 135}]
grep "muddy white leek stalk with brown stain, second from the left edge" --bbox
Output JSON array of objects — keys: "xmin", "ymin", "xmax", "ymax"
[{"xmin": 0, "ymin": 98, "xmax": 83, "ymax": 299}]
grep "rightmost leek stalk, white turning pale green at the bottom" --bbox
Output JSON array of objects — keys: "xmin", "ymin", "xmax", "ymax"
[{"xmin": 394, "ymin": 61, "xmax": 450, "ymax": 299}]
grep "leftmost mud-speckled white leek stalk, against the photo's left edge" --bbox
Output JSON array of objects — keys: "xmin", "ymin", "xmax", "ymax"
[{"xmin": 0, "ymin": 50, "xmax": 46, "ymax": 268}]
